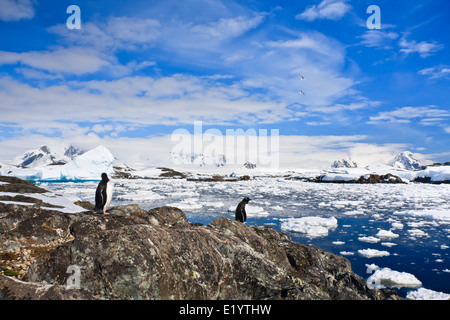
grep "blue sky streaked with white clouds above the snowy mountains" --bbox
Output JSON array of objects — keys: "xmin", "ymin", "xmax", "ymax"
[{"xmin": 0, "ymin": 0, "xmax": 450, "ymax": 167}]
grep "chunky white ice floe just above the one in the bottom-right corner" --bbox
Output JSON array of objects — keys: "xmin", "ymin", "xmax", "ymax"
[{"xmin": 367, "ymin": 268, "xmax": 422, "ymax": 289}]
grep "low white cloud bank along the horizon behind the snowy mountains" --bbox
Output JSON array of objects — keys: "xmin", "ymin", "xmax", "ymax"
[{"xmin": 0, "ymin": 127, "xmax": 406, "ymax": 173}]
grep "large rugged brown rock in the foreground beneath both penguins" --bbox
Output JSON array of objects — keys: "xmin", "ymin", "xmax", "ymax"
[{"xmin": 0, "ymin": 200, "xmax": 398, "ymax": 299}]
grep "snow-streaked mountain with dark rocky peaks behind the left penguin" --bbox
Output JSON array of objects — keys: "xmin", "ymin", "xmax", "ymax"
[{"xmin": 12, "ymin": 145, "xmax": 83, "ymax": 168}]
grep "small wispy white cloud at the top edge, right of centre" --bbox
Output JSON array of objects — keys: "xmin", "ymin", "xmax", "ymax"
[{"xmin": 295, "ymin": 0, "xmax": 352, "ymax": 21}]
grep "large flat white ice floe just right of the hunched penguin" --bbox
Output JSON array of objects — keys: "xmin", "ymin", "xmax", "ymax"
[{"xmin": 280, "ymin": 217, "xmax": 338, "ymax": 238}]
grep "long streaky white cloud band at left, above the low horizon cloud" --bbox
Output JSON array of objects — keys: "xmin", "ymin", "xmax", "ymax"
[{"xmin": 0, "ymin": 75, "xmax": 292, "ymax": 125}]
